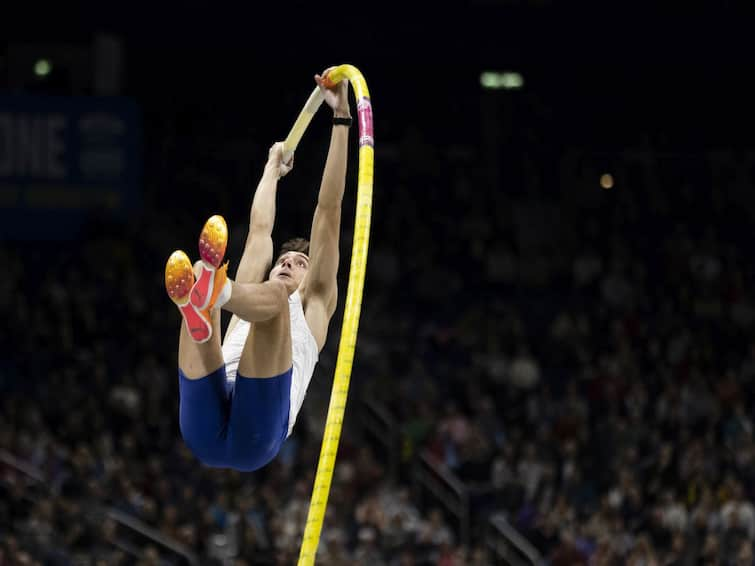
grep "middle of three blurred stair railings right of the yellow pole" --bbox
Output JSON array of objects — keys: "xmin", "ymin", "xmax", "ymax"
[{"xmin": 414, "ymin": 453, "xmax": 470, "ymax": 546}]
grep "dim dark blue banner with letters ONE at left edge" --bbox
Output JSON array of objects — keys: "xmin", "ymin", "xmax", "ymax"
[{"xmin": 0, "ymin": 96, "xmax": 142, "ymax": 240}]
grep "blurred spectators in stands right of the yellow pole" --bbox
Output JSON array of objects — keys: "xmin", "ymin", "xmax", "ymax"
[{"xmin": 358, "ymin": 130, "xmax": 755, "ymax": 565}]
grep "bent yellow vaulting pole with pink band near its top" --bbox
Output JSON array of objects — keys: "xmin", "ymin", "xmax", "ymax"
[{"xmin": 284, "ymin": 65, "xmax": 375, "ymax": 566}]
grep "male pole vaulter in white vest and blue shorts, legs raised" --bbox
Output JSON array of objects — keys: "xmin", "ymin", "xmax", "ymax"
[{"xmin": 165, "ymin": 69, "xmax": 351, "ymax": 471}]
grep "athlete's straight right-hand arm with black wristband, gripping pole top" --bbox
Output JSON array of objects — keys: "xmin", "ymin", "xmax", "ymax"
[{"xmin": 302, "ymin": 69, "xmax": 351, "ymax": 349}]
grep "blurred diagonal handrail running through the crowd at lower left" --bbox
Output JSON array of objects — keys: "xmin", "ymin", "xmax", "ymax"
[{"xmin": 0, "ymin": 450, "xmax": 199, "ymax": 566}]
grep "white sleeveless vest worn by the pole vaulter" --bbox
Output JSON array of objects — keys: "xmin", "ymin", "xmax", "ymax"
[{"xmin": 223, "ymin": 291, "xmax": 320, "ymax": 436}]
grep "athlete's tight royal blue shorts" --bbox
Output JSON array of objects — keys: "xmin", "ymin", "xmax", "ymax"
[{"xmin": 178, "ymin": 366, "xmax": 292, "ymax": 472}]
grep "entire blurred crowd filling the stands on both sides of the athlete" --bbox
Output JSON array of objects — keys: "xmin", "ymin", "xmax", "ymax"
[{"xmin": 0, "ymin": 79, "xmax": 755, "ymax": 566}]
